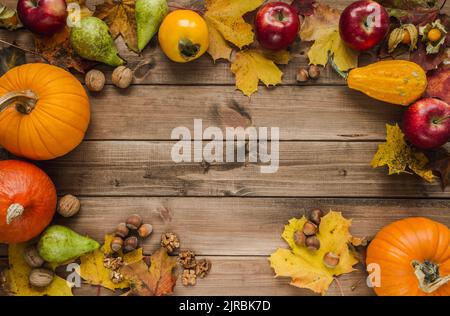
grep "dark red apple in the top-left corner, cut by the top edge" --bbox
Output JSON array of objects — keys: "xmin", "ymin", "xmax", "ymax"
[{"xmin": 17, "ymin": 0, "xmax": 67, "ymax": 36}]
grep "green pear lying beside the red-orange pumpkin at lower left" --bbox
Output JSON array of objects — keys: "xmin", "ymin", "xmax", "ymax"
[{"xmin": 38, "ymin": 225, "xmax": 100, "ymax": 264}]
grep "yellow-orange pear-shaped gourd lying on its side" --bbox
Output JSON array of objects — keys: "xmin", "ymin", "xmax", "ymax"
[{"xmin": 347, "ymin": 60, "xmax": 427, "ymax": 105}]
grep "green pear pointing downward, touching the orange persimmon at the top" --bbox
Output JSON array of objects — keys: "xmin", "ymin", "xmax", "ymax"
[{"xmin": 135, "ymin": 0, "xmax": 169, "ymax": 51}]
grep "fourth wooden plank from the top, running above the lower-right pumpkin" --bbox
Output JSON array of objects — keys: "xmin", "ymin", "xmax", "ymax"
[{"xmin": 0, "ymin": 197, "xmax": 450, "ymax": 257}]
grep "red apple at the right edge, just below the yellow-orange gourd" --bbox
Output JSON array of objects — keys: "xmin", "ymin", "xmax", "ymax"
[{"xmin": 403, "ymin": 98, "xmax": 450, "ymax": 149}]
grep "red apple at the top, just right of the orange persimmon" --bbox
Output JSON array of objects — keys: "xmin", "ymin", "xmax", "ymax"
[{"xmin": 255, "ymin": 2, "xmax": 300, "ymax": 50}]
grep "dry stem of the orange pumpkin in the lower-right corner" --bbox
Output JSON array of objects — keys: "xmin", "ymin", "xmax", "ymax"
[{"xmin": 411, "ymin": 260, "xmax": 450, "ymax": 294}]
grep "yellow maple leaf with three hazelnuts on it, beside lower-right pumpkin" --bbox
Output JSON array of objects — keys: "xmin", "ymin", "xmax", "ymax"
[{"xmin": 269, "ymin": 211, "xmax": 358, "ymax": 295}]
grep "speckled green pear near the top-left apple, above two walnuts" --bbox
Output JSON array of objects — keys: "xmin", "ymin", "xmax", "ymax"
[{"xmin": 70, "ymin": 16, "xmax": 125, "ymax": 67}]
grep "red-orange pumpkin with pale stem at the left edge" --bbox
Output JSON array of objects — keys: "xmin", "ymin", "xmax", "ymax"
[{"xmin": 0, "ymin": 160, "xmax": 56, "ymax": 243}]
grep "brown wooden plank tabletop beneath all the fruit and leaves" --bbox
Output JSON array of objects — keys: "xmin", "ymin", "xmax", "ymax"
[{"xmin": 0, "ymin": 0, "xmax": 450, "ymax": 295}]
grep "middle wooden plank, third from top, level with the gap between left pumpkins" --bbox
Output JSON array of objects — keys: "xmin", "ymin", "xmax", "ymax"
[{"xmin": 10, "ymin": 141, "xmax": 450, "ymax": 198}]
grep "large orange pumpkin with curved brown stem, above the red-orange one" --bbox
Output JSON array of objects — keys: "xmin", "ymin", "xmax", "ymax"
[{"xmin": 0, "ymin": 63, "xmax": 90, "ymax": 160}]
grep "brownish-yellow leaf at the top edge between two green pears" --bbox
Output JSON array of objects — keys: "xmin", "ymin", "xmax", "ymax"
[{"xmin": 94, "ymin": 0, "xmax": 138, "ymax": 52}]
